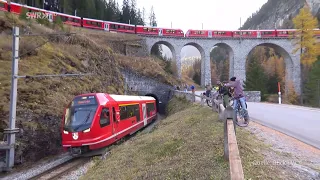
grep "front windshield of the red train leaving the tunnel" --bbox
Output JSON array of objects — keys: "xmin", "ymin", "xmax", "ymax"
[{"xmin": 64, "ymin": 96, "xmax": 98, "ymax": 132}]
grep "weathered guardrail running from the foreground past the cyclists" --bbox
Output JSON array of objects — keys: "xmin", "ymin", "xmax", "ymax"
[{"xmin": 175, "ymin": 91, "xmax": 244, "ymax": 180}]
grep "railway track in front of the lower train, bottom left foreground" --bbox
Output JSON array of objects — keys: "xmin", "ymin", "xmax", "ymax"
[{"xmin": 31, "ymin": 157, "xmax": 91, "ymax": 180}]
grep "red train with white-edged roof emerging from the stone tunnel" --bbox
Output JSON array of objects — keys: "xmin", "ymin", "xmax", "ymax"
[{"xmin": 61, "ymin": 93, "xmax": 157, "ymax": 154}]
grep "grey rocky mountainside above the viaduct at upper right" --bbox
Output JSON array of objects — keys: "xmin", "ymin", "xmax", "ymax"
[{"xmin": 241, "ymin": 0, "xmax": 320, "ymax": 29}]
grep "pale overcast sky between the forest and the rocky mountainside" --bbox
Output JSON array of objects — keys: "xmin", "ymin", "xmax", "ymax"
[{"xmin": 133, "ymin": 0, "xmax": 268, "ymax": 32}]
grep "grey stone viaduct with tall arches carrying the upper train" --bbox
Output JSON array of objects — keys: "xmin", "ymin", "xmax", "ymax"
[{"xmin": 142, "ymin": 36, "xmax": 301, "ymax": 94}]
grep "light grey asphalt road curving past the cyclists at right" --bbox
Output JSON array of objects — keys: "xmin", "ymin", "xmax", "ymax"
[{"xmin": 192, "ymin": 91, "xmax": 320, "ymax": 149}]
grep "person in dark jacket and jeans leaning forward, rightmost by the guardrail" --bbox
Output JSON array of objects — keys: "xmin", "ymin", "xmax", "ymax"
[{"xmin": 225, "ymin": 77, "xmax": 249, "ymax": 122}]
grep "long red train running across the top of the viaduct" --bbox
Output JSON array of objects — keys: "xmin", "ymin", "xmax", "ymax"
[{"xmin": 0, "ymin": 0, "xmax": 320, "ymax": 38}]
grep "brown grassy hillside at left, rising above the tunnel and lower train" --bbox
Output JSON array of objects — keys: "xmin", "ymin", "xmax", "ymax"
[{"xmin": 0, "ymin": 12, "xmax": 178, "ymax": 166}]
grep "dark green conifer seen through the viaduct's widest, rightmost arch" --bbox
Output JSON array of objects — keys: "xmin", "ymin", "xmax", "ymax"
[{"xmin": 245, "ymin": 58, "xmax": 267, "ymax": 100}]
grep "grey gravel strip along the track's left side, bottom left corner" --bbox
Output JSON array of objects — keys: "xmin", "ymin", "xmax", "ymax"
[{"xmin": 2, "ymin": 153, "xmax": 72, "ymax": 180}]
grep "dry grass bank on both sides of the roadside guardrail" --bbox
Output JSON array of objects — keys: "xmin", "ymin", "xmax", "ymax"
[{"xmin": 82, "ymin": 98, "xmax": 292, "ymax": 179}]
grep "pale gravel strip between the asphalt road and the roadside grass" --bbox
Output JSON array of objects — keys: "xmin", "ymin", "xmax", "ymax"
[{"xmin": 246, "ymin": 121, "xmax": 320, "ymax": 180}]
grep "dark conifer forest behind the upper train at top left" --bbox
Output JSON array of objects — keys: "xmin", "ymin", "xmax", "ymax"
[{"xmin": 11, "ymin": 0, "xmax": 157, "ymax": 26}]
